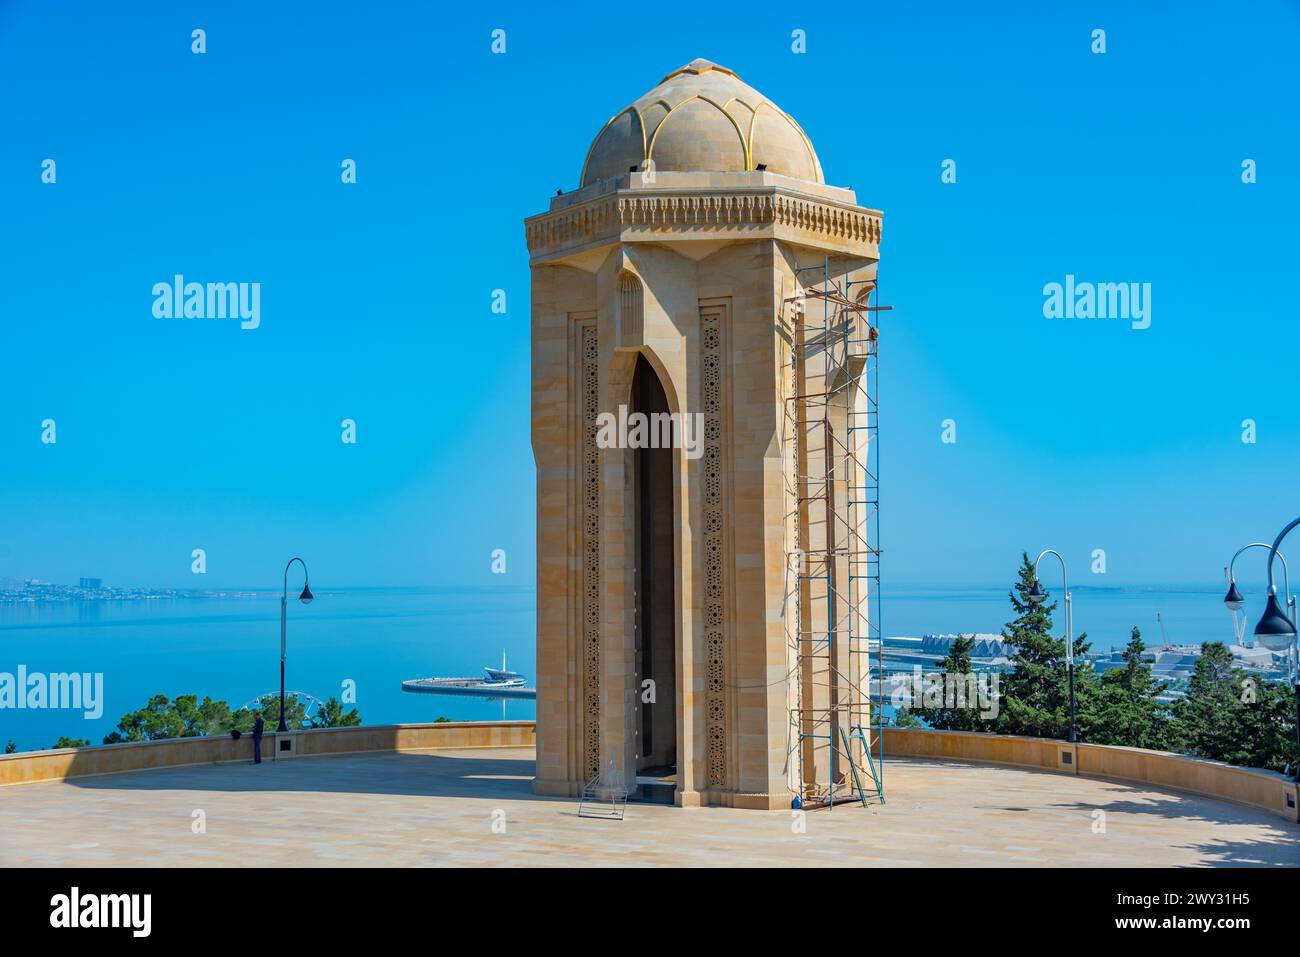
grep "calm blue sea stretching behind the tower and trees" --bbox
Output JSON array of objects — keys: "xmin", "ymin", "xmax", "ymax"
[{"xmin": 0, "ymin": 579, "xmax": 1261, "ymax": 749}]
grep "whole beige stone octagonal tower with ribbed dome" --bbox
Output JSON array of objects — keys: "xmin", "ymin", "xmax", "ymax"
[{"xmin": 525, "ymin": 60, "xmax": 881, "ymax": 807}]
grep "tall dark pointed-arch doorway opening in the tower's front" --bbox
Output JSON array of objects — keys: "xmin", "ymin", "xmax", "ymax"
[{"xmin": 629, "ymin": 356, "xmax": 677, "ymax": 800}]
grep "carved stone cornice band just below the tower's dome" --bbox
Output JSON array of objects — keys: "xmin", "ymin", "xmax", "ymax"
[{"xmin": 524, "ymin": 187, "xmax": 881, "ymax": 264}]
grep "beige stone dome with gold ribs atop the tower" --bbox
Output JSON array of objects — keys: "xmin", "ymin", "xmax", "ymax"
[{"xmin": 582, "ymin": 60, "xmax": 824, "ymax": 186}]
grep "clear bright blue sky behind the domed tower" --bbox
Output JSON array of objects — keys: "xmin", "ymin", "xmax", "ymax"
[{"xmin": 0, "ymin": 0, "xmax": 1300, "ymax": 588}]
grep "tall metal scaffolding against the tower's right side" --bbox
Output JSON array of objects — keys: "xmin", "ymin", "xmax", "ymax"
[{"xmin": 781, "ymin": 257, "xmax": 891, "ymax": 807}]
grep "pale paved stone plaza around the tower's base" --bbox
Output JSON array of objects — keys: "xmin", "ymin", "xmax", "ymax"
[{"xmin": 0, "ymin": 748, "xmax": 1300, "ymax": 867}]
